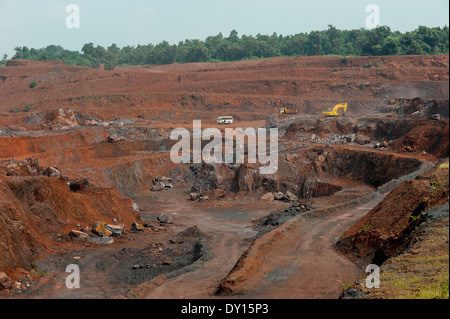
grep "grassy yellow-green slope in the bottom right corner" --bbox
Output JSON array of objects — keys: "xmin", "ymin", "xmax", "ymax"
[{"xmin": 339, "ymin": 201, "xmax": 449, "ymax": 299}]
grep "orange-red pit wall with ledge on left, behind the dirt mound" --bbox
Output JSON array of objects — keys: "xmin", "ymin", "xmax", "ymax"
[{"xmin": 0, "ymin": 128, "xmax": 185, "ymax": 196}]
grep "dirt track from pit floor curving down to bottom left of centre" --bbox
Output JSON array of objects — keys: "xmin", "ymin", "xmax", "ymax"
[{"xmin": 128, "ymin": 192, "xmax": 285, "ymax": 299}]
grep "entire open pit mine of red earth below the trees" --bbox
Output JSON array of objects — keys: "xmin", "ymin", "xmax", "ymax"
[{"xmin": 0, "ymin": 54, "xmax": 449, "ymax": 299}]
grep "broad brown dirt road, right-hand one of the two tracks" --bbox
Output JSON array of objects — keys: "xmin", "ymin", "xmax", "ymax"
[{"xmin": 218, "ymin": 193, "xmax": 385, "ymax": 299}]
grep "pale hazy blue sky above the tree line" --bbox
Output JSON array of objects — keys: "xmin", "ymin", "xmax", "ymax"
[{"xmin": 0, "ymin": 0, "xmax": 449, "ymax": 59}]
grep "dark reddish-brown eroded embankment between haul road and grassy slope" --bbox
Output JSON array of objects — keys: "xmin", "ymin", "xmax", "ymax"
[{"xmin": 336, "ymin": 160, "xmax": 449, "ymax": 265}]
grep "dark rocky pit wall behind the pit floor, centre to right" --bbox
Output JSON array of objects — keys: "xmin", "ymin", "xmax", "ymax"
[{"xmin": 186, "ymin": 145, "xmax": 422, "ymax": 198}]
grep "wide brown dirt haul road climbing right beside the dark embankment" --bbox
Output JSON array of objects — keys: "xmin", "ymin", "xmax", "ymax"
[{"xmin": 241, "ymin": 194, "xmax": 384, "ymax": 299}]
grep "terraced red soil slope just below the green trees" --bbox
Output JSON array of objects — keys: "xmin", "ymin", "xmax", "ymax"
[{"xmin": 0, "ymin": 55, "xmax": 449, "ymax": 124}]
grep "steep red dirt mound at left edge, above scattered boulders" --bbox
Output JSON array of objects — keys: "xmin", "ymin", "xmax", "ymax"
[{"xmin": 0, "ymin": 175, "xmax": 137, "ymax": 272}]
